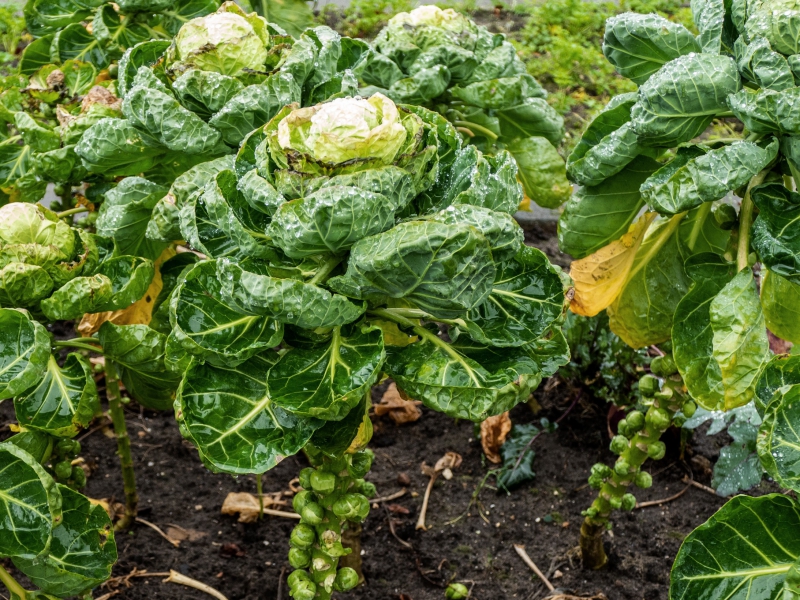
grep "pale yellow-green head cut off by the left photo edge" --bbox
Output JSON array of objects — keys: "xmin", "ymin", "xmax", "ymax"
[{"xmin": 0, "ymin": 202, "xmax": 75, "ymax": 256}]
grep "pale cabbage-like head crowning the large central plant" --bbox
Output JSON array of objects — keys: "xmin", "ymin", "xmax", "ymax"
[{"xmin": 278, "ymin": 94, "xmax": 408, "ymax": 165}]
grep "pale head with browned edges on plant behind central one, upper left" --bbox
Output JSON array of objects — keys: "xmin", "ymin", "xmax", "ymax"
[{"xmin": 170, "ymin": 2, "xmax": 269, "ymax": 76}]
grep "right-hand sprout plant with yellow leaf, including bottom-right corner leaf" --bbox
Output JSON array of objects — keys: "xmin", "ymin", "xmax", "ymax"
[{"xmin": 559, "ymin": 0, "xmax": 800, "ymax": 599}]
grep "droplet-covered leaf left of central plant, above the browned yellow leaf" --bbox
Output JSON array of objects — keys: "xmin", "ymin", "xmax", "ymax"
[{"xmin": 97, "ymin": 177, "xmax": 168, "ymax": 260}]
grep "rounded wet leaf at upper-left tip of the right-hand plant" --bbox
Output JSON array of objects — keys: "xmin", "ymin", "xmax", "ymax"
[{"xmin": 603, "ymin": 13, "xmax": 700, "ymax": 85}]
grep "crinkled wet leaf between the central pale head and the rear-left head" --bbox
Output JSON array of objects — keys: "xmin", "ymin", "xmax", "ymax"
[{"xmin": 208, "ymin": 72, "xmax": 301, "ymax": 146}]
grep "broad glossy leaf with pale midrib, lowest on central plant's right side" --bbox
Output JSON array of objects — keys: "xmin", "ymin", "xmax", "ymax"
[{"xmin": 385, "ymin": 332, "xmax": 542, "ymax": 422}]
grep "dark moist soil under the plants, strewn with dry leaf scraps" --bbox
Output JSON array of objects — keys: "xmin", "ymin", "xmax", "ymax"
[{"xmin": 0, "ymin": 224, "xmax": 756, "ymax": 600}]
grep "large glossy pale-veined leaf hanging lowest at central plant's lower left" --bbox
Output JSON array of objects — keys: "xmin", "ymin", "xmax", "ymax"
[{"xmin": 176, "ymin": 351, "xmax": 322, "ymax": 474}]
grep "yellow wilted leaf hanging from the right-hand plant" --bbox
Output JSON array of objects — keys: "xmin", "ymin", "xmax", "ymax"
[{"xmin": 569, "ymin": 212, "xmax": 656, "ymax": 317}]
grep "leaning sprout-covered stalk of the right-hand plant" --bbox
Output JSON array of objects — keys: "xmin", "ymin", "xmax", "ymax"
[{"xmin": 580, "ymin": 355, "xmax": 695, "ymax": 569}]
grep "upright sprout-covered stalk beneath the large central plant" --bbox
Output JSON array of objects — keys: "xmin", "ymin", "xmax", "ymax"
[{"xmin": 288, "ymin": 450, "xmax": 374, "ymax": 600}]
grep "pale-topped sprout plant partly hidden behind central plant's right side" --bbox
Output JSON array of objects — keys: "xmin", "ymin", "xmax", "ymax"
[{"xmin": 361, "ymin": 5, "xmax": 571, "ymax": 208}]
